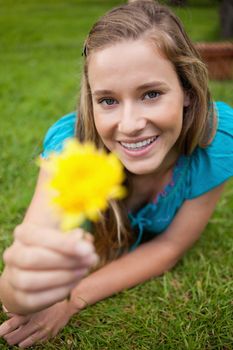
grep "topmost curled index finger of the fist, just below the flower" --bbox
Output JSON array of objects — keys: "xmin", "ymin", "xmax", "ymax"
[{"xmin": 14, "ymin": 224, "xmax": 94, "ymax": 256}]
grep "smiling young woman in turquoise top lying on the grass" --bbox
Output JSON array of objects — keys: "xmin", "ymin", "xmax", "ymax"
[{"xmin": 0, "ymin": 0, "xmax": 233, "ymax": 347}]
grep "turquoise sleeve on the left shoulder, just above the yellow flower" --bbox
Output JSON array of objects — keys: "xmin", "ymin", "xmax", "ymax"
[{"xmin": 41, "ymin": 112, "xmax": 76, "ymax": 158}]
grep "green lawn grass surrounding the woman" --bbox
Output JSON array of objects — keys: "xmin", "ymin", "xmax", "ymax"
[{"xmin": 0, "ymin": 0, "xmax": 233, "ymax": 350}]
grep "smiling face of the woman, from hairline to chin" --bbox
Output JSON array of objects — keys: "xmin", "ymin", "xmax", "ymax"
[{"xmin": 88, "ymin": 40, "xmax": 188, "ymax": 175}]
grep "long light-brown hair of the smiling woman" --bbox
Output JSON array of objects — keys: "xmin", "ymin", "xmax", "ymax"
[{"xmin": 76, "ymin": 0, "xmax": 215, "ymax": 266}]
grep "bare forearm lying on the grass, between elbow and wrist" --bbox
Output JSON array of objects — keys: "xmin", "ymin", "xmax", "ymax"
[{"xmin": 71, "ymin": 238, "xmax": 181, "ymax": 308}]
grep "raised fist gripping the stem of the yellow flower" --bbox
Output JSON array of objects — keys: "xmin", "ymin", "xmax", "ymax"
[{"xmin": 1, "ymin": 223, "xmax": 98, "ymax": 315}]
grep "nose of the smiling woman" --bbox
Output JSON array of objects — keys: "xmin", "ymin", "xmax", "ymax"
[{"xmin": 118, "ymin": 102, "xmax": 146, "ymax": 136}]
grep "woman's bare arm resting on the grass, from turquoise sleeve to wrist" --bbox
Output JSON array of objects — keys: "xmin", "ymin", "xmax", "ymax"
[{"xmin": 71, "ymin": 185, "xmax": 223, "ymax": 309}]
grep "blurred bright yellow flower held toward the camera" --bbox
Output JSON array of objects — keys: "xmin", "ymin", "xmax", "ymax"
[{"xmin": 40, "ymin": 139, "xmax": 126, "ymax": 231}]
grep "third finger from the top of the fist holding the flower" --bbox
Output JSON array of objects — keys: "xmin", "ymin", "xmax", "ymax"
[{"xmin": 11, "ymin": 268, "xmax": 89, "ymax": 292}]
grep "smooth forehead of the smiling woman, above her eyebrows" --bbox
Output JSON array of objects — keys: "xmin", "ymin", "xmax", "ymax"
[{"xmin": 88, "ymin": 40, "xmax": 178, "ymax": 90}]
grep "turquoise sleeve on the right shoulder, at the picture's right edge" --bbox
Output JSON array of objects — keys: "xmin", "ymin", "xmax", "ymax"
[{"xmin": 187, "ymin": 102, "xmax": 233, "ymax": 199}]
